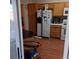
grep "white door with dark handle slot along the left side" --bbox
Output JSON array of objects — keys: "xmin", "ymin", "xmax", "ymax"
[{"xmin": 10, "ymin": 0, "xmax": 24, "ymax": 59}]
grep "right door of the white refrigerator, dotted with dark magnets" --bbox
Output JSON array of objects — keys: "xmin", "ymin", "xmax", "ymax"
[{"xmin": 42, "ymin": 10, "xmax": 52, "ymax": 37}]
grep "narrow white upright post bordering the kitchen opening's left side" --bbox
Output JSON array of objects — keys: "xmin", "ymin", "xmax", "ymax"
[{"xmin": 16, "ymin": 0, "xmax": 24, "ymax": 59}]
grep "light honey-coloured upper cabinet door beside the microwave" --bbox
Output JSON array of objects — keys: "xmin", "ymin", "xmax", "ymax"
[{"xmin": 54, "ymin": 3, "xmax": 64, "ymax": 16}]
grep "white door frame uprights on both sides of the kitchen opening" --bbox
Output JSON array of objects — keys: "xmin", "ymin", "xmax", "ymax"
[{"xmin": 18, "ymin": 0, "xmax": 69, "ymax": 59}]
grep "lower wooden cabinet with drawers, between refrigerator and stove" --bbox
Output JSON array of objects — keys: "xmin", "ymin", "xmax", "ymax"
[{"xmin": 50, "ymin": 25, "xmax": 61, "ymax": 39}]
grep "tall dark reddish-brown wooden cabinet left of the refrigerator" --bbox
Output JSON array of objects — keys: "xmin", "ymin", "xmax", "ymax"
[{"xmin": 28, "ymin": 4, "xmax": 37, "ymax": 35}]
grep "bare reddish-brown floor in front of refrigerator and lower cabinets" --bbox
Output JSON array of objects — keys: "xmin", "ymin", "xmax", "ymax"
[{"xmin": 23, "ymin": 38, "xmax": 64, "ymax": 59}]
